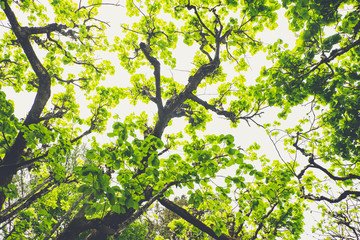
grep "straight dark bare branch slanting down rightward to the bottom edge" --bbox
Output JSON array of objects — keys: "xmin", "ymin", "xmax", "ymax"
[{"xmin": 158, "ymin": 198, "xmax": 232, "ymax": 240}]
